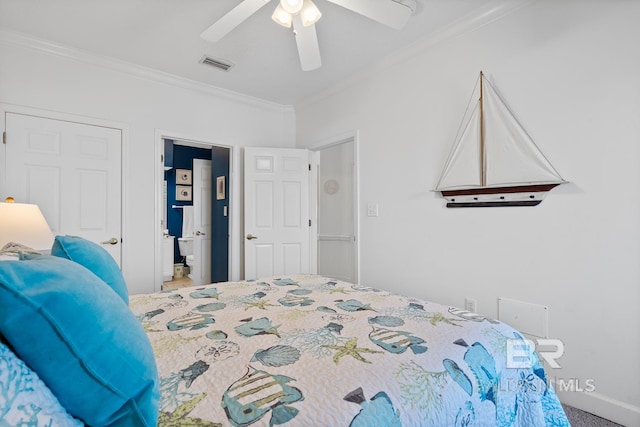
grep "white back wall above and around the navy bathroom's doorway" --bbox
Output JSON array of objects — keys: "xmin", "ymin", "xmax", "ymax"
[{"xmin": 0, "ymin": 33, "xmax": 294, "ymax": 293}]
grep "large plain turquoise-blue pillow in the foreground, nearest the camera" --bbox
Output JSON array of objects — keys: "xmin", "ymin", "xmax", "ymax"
[{"xmin": 0, "ymin": 255, "xmax": 159, "ymax": 427}]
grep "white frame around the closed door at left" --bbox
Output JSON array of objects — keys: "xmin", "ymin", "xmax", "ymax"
[{"xmin": 0, "ymin": 102, "xmax": 130, "ymax": 270}]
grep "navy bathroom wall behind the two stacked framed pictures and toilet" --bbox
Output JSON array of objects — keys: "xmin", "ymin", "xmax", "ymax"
[{"xmin": 164, "ymin": 140, "xmax": 212, "ymax": 263}]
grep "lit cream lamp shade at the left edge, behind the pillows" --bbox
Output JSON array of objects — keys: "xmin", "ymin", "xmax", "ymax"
[{"xmin": 0, "ymin": 203, "xmax": 53, "ymax": 250}]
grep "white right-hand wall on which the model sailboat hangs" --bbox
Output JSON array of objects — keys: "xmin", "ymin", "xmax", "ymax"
[{"xmin": 296, "ymin": 0, "xmax": 640, "ymax": 425}]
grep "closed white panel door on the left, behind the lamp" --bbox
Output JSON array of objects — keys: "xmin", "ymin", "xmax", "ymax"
[{"xmin": 5, "ymin": 113, "xmax": 122, "ymax": 265}]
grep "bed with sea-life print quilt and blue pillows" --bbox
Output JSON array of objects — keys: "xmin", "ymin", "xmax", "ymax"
[{"xmin": 0, "ymin": 239, "xmax": 569, "ymax": 426}]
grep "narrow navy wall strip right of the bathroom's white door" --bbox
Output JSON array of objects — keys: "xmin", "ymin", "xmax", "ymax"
[{"xmin": 211, "ymin": 147, "xmax": 231, "ymax": 283}]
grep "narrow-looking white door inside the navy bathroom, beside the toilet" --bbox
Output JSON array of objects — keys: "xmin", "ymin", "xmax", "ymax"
[{"xmin": 189, "ymin": 159, "xmax": 213, "ymax": 286}]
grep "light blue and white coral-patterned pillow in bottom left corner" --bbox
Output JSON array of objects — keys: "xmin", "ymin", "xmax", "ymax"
[{"xmin": 0, "ymin": 342, "xmax": 84, "ymax": 427}]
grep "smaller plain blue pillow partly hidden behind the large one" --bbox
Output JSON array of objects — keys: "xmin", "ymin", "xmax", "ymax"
[{"xmin": 51, "ymin": 236, "xmax": 129, "ymax": 304}]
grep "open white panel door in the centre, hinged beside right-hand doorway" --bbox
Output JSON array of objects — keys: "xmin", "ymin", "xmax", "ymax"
[{"xmin": 244, "ymin": 148, "xmax": 310, "ymax": 280}]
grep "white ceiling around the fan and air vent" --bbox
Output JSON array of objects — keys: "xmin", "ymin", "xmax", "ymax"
[{"xmin": 0, "ymin": 0, "xmax": 522, "ymax": 105}]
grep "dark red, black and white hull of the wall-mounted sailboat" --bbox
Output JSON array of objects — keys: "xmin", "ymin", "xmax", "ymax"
[{"xmin": 441, "ymin": 183, "xmax": 560, "ymax": 208}]
